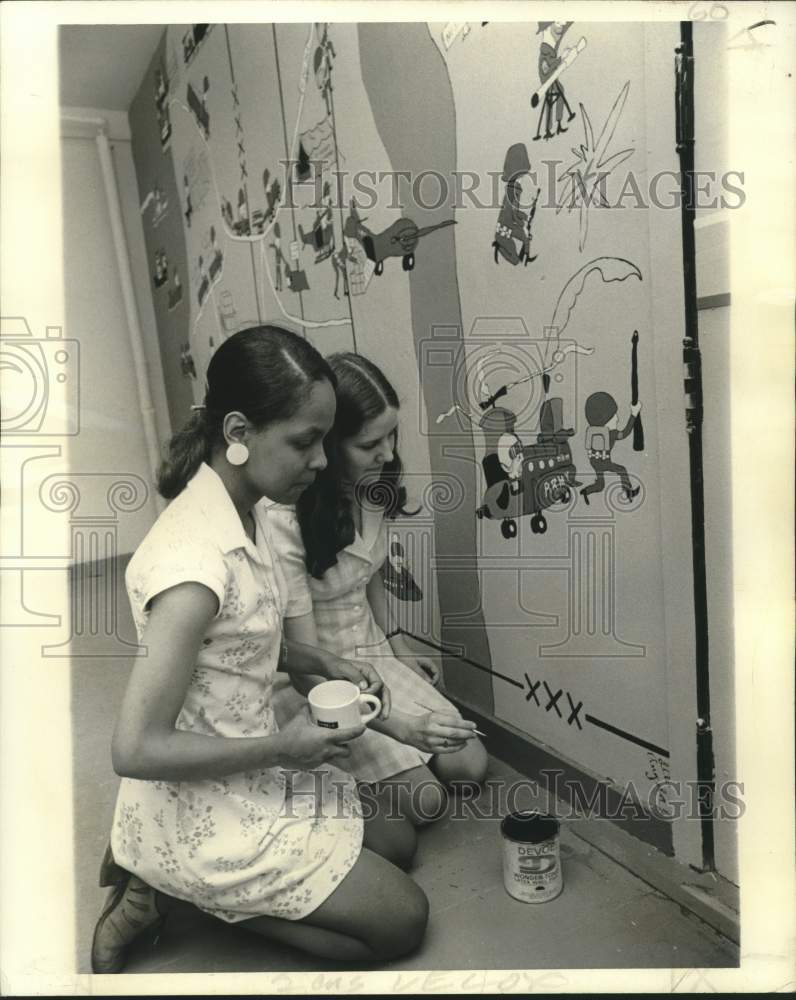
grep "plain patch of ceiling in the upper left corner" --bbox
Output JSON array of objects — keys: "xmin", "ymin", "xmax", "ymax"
[{"xmin": 58, "ymin": 24, "xmax": 165, "ymax": 111}]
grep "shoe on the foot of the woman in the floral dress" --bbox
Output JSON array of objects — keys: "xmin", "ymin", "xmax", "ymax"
[{"xmin": 91, "ymin": 847, "xmax": 165, "ymax": 974}]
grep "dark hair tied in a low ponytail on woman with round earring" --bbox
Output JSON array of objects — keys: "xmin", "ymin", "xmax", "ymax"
[{"xmin": 157, "ymin": 326, "xmax": 336, "ymax": 500}]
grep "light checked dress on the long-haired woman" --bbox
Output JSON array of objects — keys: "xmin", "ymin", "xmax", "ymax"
[{"xmin": 267, "ymin": 504, "xmax": 459, "ymax": 782}]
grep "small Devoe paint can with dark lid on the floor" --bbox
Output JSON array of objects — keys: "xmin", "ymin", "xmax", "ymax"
[{"xmin": 500, "ymin": 811, "xmax": 564, "ymax": 903}]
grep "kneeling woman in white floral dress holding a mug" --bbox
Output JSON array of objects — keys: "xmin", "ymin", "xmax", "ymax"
[{"xmin": 92, "ymin": 327, "xmax": 427, "ymax": 972}]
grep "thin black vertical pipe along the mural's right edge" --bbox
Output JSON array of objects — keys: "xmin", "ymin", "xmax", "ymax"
[{"xmin": 675, "ymin": 21, "xmax": 715, "ymax": 870}]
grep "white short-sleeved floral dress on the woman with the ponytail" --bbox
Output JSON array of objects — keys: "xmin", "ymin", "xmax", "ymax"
[{"xmin": 111, "ymin": 464, "xmax": 363, "ymax": 923}]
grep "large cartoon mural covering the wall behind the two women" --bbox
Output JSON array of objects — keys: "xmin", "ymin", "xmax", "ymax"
[{"xmin": 131, "ymin": 22, "xmax": 684, "ymax": 812}]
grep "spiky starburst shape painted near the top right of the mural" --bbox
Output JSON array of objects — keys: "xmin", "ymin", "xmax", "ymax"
[{"xmin": 556, "ymin": 80, "xmax": 635, "ymax": 251}]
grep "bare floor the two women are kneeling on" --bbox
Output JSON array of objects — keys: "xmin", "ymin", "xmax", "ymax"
[{"xmin": 73, "ymin": 656, "xmax": 738, "ymax": 973}]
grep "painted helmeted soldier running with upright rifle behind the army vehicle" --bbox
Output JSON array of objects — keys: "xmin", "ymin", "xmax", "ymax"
[{"xmin": 580, "ymin": 331, "xmax": 644, "ymax": 505}]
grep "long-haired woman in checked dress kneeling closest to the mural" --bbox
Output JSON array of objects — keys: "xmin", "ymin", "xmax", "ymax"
[{"xmin": 269, "ymin": 353, "xmax": 487, "ymax": 825}]
